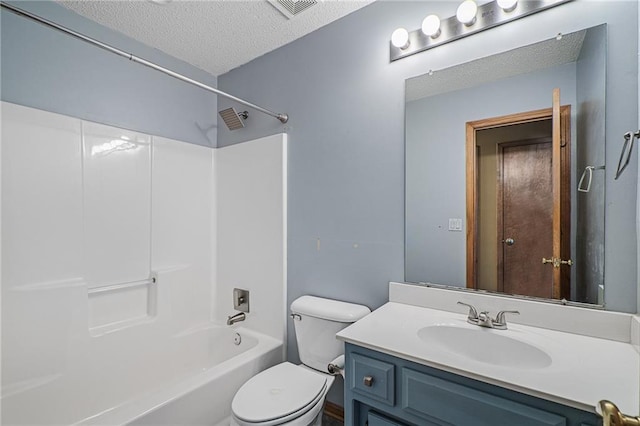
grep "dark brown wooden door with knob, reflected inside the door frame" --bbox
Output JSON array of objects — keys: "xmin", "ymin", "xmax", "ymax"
[{"xmin": 497, "ymin": 137, "xmax": 554, "ymax": 298}]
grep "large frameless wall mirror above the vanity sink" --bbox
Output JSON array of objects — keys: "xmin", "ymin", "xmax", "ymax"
[{"xmin": 405, "ymin": 24, "xmax": 607, "ymax": 305}]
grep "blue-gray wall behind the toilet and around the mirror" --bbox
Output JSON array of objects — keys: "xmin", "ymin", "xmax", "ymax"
[{"xmin": 218, "ymin": 0, "xmax": 638, "ymax": 401}]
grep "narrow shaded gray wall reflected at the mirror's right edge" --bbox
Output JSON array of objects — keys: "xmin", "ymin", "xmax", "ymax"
[{"xmin": 571, "ymin": 26, "xmax": 604, "ymax": 303}]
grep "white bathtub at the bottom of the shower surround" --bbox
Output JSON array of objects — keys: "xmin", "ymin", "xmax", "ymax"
[{"xmin": 2, "ymin": 324, "xmax": 284, "ymax": 426}]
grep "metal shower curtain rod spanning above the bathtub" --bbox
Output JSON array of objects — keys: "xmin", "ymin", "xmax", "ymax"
[{"xmin": 0, "ymin": 1, "xmax": 289, "ymax": 123}]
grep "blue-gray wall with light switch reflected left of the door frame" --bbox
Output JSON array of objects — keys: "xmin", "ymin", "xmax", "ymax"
[{"xmin": 404, "ymin": 63, "xmax": 576, "ymax": 288}]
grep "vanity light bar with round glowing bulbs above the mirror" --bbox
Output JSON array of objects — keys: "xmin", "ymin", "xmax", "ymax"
[{"xmin": 389, "ymin": 0, "xmax": 573, "ymax": 61}]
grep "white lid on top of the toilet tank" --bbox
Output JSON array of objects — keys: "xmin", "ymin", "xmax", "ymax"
[{"xmin": 291, "ymin": 296, "xmax": 371, "ymax": 322}]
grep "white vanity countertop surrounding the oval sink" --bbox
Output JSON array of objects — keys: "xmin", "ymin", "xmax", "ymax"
[{"xmin": 337, "ymin": 302, "xmax": 640, "ymax": 415}]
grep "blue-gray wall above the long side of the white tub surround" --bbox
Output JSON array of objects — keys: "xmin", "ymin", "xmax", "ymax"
[{"xmin": 0, "ymin": 1, "xmax": 217, "ymax": 146}]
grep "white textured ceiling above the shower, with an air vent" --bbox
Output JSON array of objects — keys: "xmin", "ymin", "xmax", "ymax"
[{"xmin": 58, "ymin": 0, "xmax": 373, "ymax": 76}]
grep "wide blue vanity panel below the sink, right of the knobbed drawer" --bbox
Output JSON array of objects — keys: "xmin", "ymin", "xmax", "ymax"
[{"xmin": 401, "ymin": 368, "xmax": 567, "ymax": 426}]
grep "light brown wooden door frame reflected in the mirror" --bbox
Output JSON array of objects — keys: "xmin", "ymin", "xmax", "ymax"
[{"xmin": 465, "ymin": 105, "xmax": 571, "ymax": 299}]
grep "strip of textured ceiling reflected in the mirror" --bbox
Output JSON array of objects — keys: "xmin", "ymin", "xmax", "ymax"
[{"xmin": 406, "ymin": 31, "xmax": 586, "ymax": 102}]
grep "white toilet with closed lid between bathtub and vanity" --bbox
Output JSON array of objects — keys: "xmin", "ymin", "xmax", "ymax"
[{"xmin": 231, "ymin": 296, "xmax": 371, "ymax": 426}]
